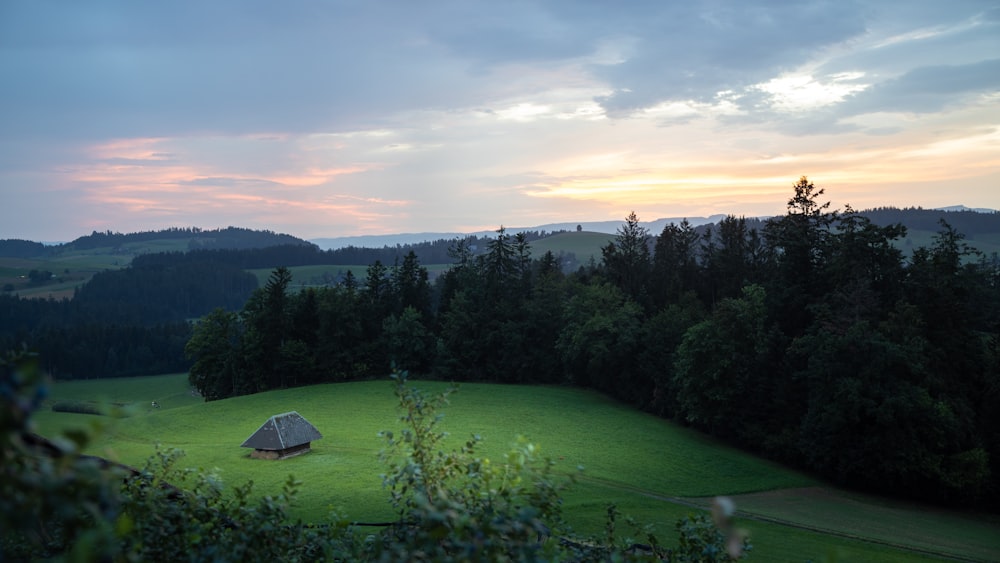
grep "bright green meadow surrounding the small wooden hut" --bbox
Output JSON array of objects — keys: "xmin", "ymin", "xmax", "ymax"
[{"xmin": 36, "ymin": 374, "xmax": 1000, "ymax": 561}]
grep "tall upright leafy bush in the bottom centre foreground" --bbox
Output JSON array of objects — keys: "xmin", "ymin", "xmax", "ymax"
[{"xmin": 370, "ymin": 372, "xmax": 569, "ymax": 561}]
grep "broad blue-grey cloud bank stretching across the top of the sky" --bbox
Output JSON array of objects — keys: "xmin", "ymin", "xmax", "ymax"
[{"xmin": 0, "ymin": 1, "xmax": 876, "ymax": 138}]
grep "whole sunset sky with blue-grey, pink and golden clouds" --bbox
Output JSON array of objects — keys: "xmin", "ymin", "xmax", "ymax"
[{"xmin": 0, "ymin": 0, "xmax": 1000, "ymax": 241}]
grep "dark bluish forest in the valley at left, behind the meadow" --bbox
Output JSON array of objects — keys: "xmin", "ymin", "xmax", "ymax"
[{"xmin": 0, "ymin": 259, "xmax": 257, "ymax": 379}]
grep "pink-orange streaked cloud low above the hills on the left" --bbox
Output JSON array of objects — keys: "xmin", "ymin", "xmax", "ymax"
[{"xmin": 67, "ymin": 138, "xmax": 411, "ymax": 235}]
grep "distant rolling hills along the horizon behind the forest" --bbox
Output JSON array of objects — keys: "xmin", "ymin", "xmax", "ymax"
[{"xmin": 0, "ymin": 206, "xmax": 1000, "ymax": 299}]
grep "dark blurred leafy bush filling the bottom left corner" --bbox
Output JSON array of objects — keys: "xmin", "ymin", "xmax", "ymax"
[{"xmin": 0, "ymin": 353, "xmax": 352, "ymax": 561}]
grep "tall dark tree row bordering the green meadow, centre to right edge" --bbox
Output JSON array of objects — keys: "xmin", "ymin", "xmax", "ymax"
[{"xmin": 186, "ymin": 178, "xmax": 1000, "ymax": 502}]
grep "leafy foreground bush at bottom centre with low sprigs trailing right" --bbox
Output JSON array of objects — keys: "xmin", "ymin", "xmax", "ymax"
[{"xmin": 365, "ymin": 372, "xmax": 751, "ymax": 563}]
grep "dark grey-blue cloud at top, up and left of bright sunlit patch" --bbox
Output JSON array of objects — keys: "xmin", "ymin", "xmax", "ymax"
[{"xmin": 595, "ymin": 2, "xmax": 864, "ymax": 116}]
